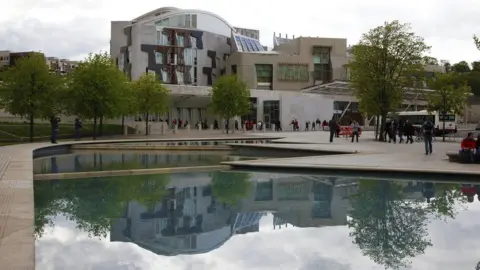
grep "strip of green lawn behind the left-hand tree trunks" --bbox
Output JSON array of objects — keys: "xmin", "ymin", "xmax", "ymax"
[{"xmin": 0, "ymin": 123, "xmax": 134, "ymax": 141}]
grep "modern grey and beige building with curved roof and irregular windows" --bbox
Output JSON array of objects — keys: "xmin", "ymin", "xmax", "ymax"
[{"xmin": 110, "ymin": 7, "xmax": 456, "ymax": 129}]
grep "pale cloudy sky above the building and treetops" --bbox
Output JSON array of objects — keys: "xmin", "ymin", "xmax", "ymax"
[{"xmin": 0, "ymin": 0, "xmax": 480, "ymax": 63}]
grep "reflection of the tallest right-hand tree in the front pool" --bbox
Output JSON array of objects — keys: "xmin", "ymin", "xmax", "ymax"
[{"xmin": 348, "ymin": 180, "xmax": 431, "ymax": 269}]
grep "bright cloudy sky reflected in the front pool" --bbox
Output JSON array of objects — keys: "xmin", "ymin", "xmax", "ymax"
[{"xmin": 36, "ymin": 206, "xmax": 480, "ymax": 270}]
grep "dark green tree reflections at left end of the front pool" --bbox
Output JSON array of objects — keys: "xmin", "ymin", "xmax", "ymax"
[{"xmin": 34, "ymin": 174, "xmax": 169, "ymax": 238}]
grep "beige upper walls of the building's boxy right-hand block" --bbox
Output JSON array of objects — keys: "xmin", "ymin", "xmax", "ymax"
[{"xmin": 227, "ymin": 37, "xmax": 348, "ymax": 90}]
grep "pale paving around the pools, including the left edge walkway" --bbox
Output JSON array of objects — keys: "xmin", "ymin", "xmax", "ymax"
[{"xmin": 0, "ymin": 131, "xmax": 480, "ymax": 270}]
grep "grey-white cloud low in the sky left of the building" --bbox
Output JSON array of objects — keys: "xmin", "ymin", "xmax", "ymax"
[{"xmin": 0, "ymin": 17, "xmax": 109, "ymax": 58}]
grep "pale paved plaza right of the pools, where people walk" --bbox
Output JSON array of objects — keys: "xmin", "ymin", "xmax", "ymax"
[{"xmin": 222, "ymin": 132, "xmax": 480, "ymax": 175}]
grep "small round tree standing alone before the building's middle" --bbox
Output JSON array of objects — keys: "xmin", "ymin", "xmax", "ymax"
[{"xmin": 131, "ymin": 73, "xmax": 170, "ymax": 135}]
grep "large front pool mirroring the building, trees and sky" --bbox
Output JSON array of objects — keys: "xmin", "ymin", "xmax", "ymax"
[{"xmin": 34, "ymin": 171, "xmax": 480, "ymax": 270}]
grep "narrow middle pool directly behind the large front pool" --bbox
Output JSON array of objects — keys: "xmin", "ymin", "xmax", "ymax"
[{"xmin": 33, "ymin": 150, "xmax": 259, "ymax": 174}]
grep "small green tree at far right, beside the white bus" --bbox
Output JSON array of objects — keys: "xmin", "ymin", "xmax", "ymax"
[{"xmin": 427, "ymin": 73, "xmax": 471, "ymax": 141}]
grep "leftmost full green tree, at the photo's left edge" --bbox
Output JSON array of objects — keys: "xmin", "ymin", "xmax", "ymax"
[{"xmin": 0, "ymin": 53, "xmax": 60, "ymax": 142}]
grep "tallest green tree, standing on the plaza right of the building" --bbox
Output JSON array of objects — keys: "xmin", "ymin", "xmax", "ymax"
[{"xmin": 349, "ymin": 21, "xmax": 429, "ymax": 140}]
